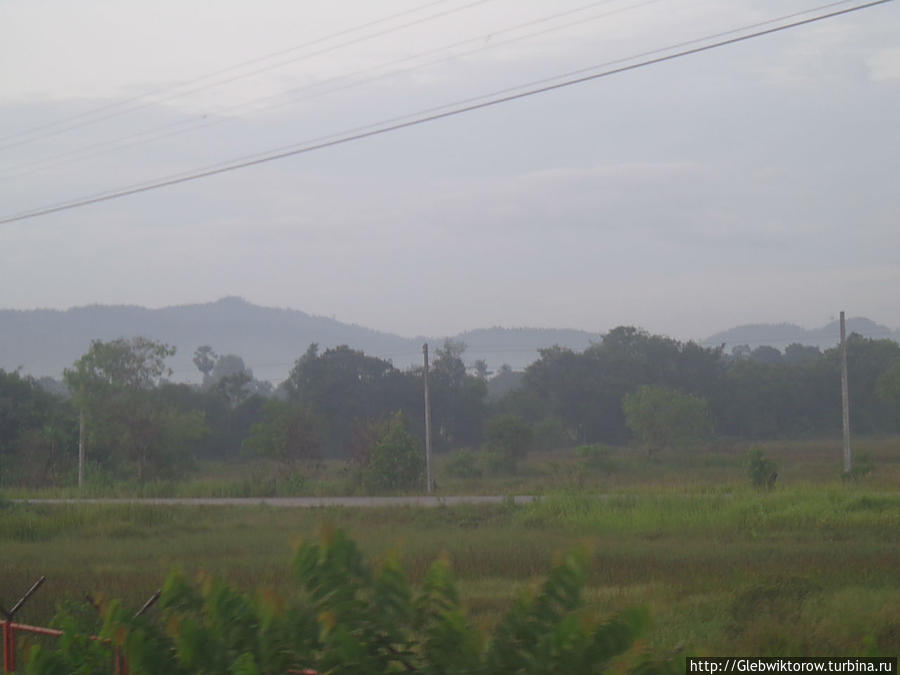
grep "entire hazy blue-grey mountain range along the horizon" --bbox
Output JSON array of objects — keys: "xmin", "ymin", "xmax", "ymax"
[{"xmin": 0, "ymin": 297, "xmax": 900, "ymax": 382}]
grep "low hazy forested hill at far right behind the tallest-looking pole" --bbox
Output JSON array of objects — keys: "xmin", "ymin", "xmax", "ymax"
[{"xmin": 703, "ymin": 317, "xmax": 900, "ymax": 352}]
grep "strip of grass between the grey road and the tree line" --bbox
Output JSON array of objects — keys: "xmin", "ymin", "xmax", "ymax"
[{"xmin": 4, "ymin": 437, "xmax": 900, "ymax": 498}]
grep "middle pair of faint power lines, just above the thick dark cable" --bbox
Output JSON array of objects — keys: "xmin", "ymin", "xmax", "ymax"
[{"xmin": 0, "ymin": 0, "xmax": 660, "ymax": 180}]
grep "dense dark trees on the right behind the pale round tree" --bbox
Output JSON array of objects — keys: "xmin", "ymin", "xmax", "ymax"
[{"xmin": 507, "ymin": 328, "xmax": 900, "ymax": 443}]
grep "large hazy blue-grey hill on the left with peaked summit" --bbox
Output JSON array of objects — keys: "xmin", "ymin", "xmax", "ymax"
[{"xmin": 0, "ymin": 298, "xmax": 416, "ymax": 381}]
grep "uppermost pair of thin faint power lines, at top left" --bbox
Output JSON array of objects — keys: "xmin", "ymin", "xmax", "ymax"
[{"xmin": 0, "ymin": 0, "xmax": 493, "ymax": 150}]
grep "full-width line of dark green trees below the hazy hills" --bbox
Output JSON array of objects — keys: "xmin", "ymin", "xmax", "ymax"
[{"xmin": 0, "ymin": 327, "xmax": 900, "ymax": 487}]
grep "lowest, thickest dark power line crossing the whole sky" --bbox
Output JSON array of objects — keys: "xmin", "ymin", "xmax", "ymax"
[{"xmin": 0, "ymin": 0, "xmax": 892, "ymax": 224}]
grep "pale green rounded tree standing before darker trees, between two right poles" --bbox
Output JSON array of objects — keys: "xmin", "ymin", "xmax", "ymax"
[{"xmin": 622, "ymin": 385, "xmax": 711, "ymax": 452}]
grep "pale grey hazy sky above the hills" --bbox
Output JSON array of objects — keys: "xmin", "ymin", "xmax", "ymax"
[{"xmin": 0, "ymin": 0, "xmax": 900, "ymax": 338}]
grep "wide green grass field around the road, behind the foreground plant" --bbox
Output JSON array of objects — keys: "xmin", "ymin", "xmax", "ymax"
[{"xmin": 0, "ymin": 439, "xmax": 900, "ymax": 656}]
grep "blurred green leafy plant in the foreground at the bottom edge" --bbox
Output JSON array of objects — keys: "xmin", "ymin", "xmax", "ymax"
[{"xmin": 27, "ymin": 529, "xmax": 675, "ymax": 675}]
